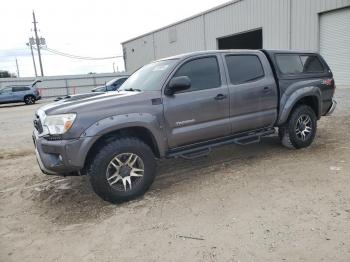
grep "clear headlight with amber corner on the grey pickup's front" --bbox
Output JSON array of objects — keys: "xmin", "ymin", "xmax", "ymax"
[{"xmin": 43, "ymin": 114, "xmax": 76, "ymax": 135}]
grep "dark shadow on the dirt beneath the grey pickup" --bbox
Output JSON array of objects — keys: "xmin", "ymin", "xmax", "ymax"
[{"xmin": 31, "ymin": 137, "xmax": 288, "ymax": 225}]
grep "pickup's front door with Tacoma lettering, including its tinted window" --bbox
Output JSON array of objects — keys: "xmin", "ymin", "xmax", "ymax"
[{"xmin": 163, "ymin": 55, "xmax": 231, "ymax": 148}]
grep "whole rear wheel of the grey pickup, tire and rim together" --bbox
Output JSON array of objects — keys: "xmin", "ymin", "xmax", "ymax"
[{"xmin": 278, "ymin": 105, "xmax": 317, "ymax": 149}]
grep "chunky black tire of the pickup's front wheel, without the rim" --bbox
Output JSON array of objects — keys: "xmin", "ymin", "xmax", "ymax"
[{"xmin": 87, "ymin": 137, "xmax": 156, "ymax": 203}]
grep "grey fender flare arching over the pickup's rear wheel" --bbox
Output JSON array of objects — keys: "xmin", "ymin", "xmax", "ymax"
[{"xmin": 277, "ymin": 86, "xmax": 322, "ymax": 125}]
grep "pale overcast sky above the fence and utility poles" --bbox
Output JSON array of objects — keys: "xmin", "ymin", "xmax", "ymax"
[{"xmin": 0, "ymin": 0, "xmax": 227, "ymax": 76}]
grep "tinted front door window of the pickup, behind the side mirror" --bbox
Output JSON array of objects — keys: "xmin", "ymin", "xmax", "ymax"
[{"xmin": 174, "ymin": 57, "xmax": 221, "ymax": 91}]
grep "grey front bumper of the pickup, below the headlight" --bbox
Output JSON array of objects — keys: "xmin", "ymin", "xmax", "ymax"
[{"xmin": 33, "ymin": 130, "xmax": 92, "ymax": 176}]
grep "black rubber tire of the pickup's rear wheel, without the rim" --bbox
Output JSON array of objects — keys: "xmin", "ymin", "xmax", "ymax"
[{"xmin": 278, "ymin": 105, "xmax": 317, "ymax": 149}]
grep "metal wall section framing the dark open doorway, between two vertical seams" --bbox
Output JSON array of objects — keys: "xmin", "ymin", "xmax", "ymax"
[{"xmin": 205, "ymin": 0, "xmax": 289, "ymax": 49}]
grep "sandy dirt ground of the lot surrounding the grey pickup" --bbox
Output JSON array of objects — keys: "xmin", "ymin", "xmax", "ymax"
[{"xmin": 0, "ymin": 89, "xmax": 350, "ymax": 262}]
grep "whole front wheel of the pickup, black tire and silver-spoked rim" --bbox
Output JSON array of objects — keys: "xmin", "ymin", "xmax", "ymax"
[{"xmin": 88, "ymin": 138, "xmax": 156, "ymax": 203}]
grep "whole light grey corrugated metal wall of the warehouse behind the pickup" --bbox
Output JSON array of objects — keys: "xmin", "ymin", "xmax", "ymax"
[{"xmin": 123, "ymin": 0, "xmax": 350, "ymax": 72}]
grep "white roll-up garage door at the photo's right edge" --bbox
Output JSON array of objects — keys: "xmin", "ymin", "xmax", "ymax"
[{"xmin": 320, "ymin": 8, "xmax": 350, "ymax": 86}]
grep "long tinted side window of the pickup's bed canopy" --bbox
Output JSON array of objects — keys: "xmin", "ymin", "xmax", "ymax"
[{"xmin": 276, "ymin": 54, "xmax": 324, "ymax": 74}]
